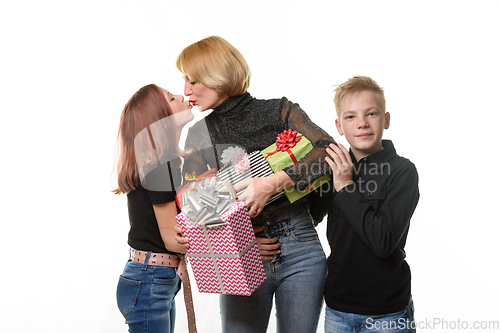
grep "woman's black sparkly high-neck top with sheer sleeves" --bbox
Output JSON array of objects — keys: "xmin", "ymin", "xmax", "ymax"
[{"xmin": 183, "ymin": 92, "xmax": 335, "ymax": 191}]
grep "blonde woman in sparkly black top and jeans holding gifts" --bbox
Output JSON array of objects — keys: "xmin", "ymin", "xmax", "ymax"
[{"xmin": 176, "ymin": 36, "xmax": 334, "ymax": 333}]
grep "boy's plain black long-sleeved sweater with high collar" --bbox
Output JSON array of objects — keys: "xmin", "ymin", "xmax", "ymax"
[{"xmin": 325, "ymin": 140, "xmax": 419, "ymax": 315}]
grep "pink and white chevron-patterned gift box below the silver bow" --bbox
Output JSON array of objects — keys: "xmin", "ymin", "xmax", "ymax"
[{"xmin": 176, "ymin": 202, "xmax": 266, "ymax": 296}]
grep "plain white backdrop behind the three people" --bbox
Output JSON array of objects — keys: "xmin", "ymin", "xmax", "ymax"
[{"xmin": 0, "ymin": 0, "xmax": 500, "ymax": 333}]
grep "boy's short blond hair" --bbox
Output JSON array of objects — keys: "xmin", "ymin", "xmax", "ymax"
[{"xmin": 333, "ymin": 76, "xmax": 385, "ymax": 117}]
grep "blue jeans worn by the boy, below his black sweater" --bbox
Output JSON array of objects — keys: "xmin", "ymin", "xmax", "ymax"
[{"xmin": 325, "ymin": 298, "xmax": 416, "ymax": 333}]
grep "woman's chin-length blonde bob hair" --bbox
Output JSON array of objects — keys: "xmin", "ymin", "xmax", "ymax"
[{"xmin": 176, "ymin": 36, "xmax": 251, "ymax": 97}]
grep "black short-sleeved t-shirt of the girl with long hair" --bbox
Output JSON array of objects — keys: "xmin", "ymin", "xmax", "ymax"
[{"xmin": 127, "ymin": 161, "xmax": 181, "ymax": 253}]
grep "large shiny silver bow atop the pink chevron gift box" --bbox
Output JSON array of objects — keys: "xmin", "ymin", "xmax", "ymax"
[{"xmin": 181, "ymin": 177, "xmax": 236, "ymax": 227}]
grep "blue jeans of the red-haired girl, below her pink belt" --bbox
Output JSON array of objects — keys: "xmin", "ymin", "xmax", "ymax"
[{"xmin": 116, "ymin": 260, "xmax": 180, "ymax": 333}]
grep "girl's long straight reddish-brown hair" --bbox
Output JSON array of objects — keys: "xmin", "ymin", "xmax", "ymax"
[{"xmin": 113, "ymin": 84, "xmax": 183, "ymax": 194}]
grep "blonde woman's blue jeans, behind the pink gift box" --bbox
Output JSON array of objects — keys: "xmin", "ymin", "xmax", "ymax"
[{"xmin": 220, "ymin": 201, "xmax": 327, "ymax": 333}]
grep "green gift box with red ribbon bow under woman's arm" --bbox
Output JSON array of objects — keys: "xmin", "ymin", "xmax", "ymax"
[{"xmin": 261, "ymin": 129, "xmax": 330, "ymax": 203}]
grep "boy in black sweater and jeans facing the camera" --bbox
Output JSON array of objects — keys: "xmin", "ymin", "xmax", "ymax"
[{"xmin": 325, "ymin": 76, "xmax": 419, "ymax": 332}]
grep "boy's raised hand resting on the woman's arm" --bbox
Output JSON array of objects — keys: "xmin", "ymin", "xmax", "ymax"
[{"xmin": 325, "ymin": 143, "xmax": 353, "ymax": 192}]
